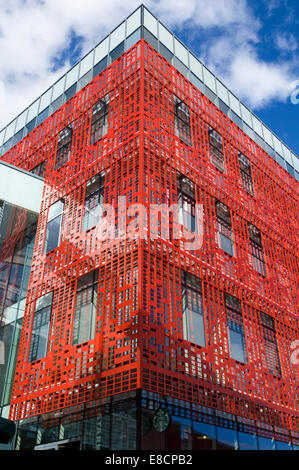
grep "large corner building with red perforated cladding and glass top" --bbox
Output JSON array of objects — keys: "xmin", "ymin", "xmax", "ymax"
[{"xmin": 0, "ymin": 6, "xmax": 299, "ymax": 450}]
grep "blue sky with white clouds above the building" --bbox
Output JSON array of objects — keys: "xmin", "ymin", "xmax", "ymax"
[{"xmin": 0, "ymin": 0, "xmax": 299, "ymax": 155}]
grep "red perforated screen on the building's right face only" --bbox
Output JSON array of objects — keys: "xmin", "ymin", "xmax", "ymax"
[{"xmin": 142, "ymin": 46, "xmax": 299, "ymax": 430}]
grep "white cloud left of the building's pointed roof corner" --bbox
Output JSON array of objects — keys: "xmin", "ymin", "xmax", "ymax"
[{"xmin": 0, "ymin": 0, "xmax": 139, "ymax": 129}]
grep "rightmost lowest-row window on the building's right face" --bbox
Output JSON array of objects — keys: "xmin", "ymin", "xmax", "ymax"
[{"xmin": 261, "ymin": 313, "xmax": 281, "ymax": 377}]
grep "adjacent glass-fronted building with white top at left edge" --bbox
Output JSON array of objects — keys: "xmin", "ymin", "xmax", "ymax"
[{"xmin": 0, "ymin": 162, "xmax": 43, "ymax": 449}]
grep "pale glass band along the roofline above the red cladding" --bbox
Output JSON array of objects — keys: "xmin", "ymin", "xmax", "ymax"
[{"xmin": 0, "ymin": 5, "xmax": 299, "ymax": 181}]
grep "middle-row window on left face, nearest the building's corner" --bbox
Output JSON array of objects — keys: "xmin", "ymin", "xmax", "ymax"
[{"xmin": 82, "ymin": 172, "xmax": 105, "ymax": 232}]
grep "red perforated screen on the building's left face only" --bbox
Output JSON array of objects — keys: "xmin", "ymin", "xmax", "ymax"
[{"xmin": 4, "ymin": 44, "xmax": 141, "ymax": 419}]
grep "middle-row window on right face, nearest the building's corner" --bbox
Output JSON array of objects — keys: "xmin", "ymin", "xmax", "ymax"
[{"xmin": 177, "ymin": 173, "xmax": 196, "ymax": 232}]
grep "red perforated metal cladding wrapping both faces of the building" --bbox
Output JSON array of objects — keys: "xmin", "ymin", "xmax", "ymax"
[{"xmin": 3, "ymin": 40, "xmax": 299, "ymax": 431}]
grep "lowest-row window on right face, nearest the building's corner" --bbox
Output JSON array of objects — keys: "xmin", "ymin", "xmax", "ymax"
[{"xmin": 182, "ymin": 271, "xmax": 206, "ymax": 346}]
